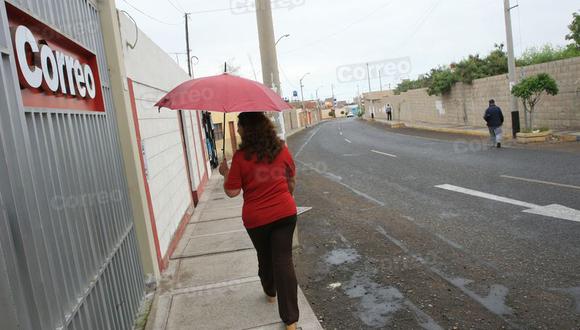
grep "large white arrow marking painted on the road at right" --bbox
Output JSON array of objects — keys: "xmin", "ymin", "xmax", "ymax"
[{"xmin": 435, "ymin": 184, "xmax": 580, "ymax": 222}]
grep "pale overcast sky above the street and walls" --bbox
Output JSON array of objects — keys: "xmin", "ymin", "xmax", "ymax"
[{"xmin": 117, "ymin": 0, "xmax": 580, "ymax": 99}]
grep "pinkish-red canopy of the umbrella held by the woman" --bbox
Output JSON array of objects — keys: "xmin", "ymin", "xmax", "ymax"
[{"xmin": 155, "ymin": 73, "xmax": 292, "ymax": 113}]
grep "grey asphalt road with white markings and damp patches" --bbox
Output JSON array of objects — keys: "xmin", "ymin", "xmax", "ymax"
[{"xmin": 289, "ymin": 119, "xmax": 580, "ymax": 329}]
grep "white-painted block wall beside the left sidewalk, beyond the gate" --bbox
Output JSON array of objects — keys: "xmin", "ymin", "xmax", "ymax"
[{"xmin": 119, "ymin": 13, "xmax": 205, "ymax": 257}]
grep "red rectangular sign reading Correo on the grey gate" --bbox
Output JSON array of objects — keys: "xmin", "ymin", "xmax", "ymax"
[{"xmin": 6, "ymin": 3, "xmax": 105, "ymax": 112}]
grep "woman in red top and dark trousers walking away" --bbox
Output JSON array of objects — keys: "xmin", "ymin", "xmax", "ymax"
[{"xmin": 219, "ymin": 112, "xmax": 299, "ymax": 329}]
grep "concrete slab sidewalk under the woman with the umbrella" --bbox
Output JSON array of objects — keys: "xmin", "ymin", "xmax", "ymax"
[{"xmin": 146, "ymin": 173, "xmax": 322, "ymax": 330}]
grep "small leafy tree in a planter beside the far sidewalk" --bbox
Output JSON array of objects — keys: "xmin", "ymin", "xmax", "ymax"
[{"xmin": 512, "ymin": 73, "xmax": 559, "ymax": 129}]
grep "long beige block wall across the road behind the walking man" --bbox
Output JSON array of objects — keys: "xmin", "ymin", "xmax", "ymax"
[{"xmin": 365, "ymin": 58, "xmax": 580, "ymax": 130}]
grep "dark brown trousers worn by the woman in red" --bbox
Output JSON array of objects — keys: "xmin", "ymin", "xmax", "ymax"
[{"xmin": 247, "ymin": 215, "xmax": 299, "ymax": 325}]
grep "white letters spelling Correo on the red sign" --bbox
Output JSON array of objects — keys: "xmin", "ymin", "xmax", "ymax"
[{"xmin": 14, "ymin": 25, "xmax": 97, "ymax": 99}]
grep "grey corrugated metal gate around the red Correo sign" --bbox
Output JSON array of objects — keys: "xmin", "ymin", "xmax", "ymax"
[{"xmin": 0, "ymin": 0, "xmax": 144, "ymax": 330}]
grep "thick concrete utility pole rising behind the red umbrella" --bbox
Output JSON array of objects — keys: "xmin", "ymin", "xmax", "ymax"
[{"xmin": 256, "ymin": 0, "xmax": 286, "ymax": 139}]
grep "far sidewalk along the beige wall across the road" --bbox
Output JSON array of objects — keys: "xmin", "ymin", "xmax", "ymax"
[{"xmin": 374, "ymin": 118, "xmax": 580, "ymax": 142}]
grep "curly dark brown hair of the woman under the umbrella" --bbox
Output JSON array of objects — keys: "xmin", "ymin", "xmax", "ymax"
[{"xmin": 238, "ymin": 112, "xmax": 285, "ymax": 163}]
